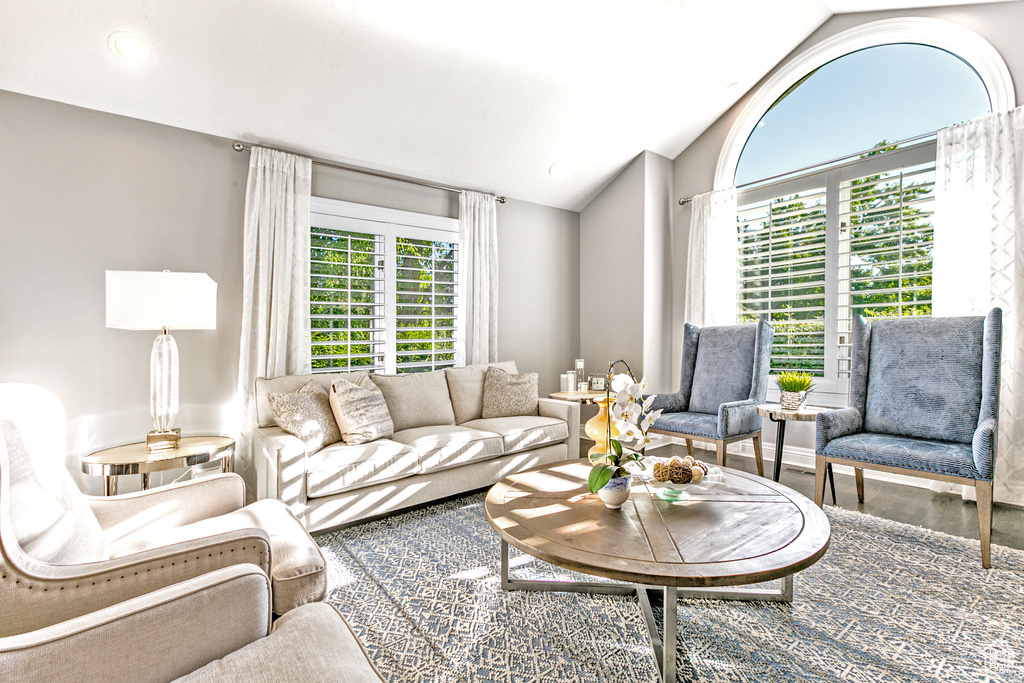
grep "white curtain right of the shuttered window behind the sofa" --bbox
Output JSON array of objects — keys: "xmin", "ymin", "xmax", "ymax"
[{"xmin": 456, "ymin": 190, "xmax": 498, "ymax": 366}]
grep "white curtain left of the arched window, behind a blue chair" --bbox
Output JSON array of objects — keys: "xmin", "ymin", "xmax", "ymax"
[{"xmin": 683, "ymin": 187, "xmax": 739, "ymax": 326}]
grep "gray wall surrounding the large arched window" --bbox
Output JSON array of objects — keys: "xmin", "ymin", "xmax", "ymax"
[{"xmin": 672, "ymin": 2, "xmax": 1024, "ymax": 456}]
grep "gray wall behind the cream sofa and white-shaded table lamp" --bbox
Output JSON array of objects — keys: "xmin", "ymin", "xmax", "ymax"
[{"xmin": 0, "ymin": 91, "xmax": 580, "ymax": 493}]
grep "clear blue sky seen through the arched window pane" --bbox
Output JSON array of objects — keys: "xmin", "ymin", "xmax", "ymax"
[{"xmin": 736, "ymin": 44, "xmax": 989, "ymax": 185}]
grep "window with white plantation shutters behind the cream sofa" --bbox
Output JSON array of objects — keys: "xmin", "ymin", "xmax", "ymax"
[{"xmin": 309, "ymin": 198, "xmax": 459, "ymax": 374}]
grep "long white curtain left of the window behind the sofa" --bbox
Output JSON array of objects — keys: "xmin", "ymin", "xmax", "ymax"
[{"xmin": 238, "ymin": 146, "xmax": 312, "ymax": 485}]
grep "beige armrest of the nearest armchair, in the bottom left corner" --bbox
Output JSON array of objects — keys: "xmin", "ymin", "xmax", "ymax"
[{"xmin": 0, "ymin": 564, "xmax": 270, "ymax": 683}]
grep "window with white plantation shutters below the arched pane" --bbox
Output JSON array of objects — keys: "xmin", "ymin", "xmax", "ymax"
[{"xmin": 736, "ymin": 141, "xmax": 935, "ymax": 392}]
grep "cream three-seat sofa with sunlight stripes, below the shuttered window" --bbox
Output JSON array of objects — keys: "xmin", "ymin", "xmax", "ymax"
[{"xmin": 252, "ymin": 361, "xmax": 580, "ymax": 531}]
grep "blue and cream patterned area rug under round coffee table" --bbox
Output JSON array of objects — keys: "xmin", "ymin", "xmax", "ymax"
[{"xmin": 316, "ymin": 494, "xmax": 1024, "ymax": 683}]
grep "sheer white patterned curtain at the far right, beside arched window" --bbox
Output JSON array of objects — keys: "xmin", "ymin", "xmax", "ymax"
[{"xmin": 932, "ymin": 108, "xmax": 1024, "ymax": 505}]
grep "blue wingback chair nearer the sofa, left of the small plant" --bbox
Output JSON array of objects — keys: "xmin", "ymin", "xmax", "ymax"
[{"xmin": 651, "ymin": 321, "xmax": 775, "ymax": 476}]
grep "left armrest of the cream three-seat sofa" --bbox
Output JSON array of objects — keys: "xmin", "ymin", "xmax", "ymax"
[{"xmin": 252, "ymin": 427, "xmax": 307, "ymax": 526}]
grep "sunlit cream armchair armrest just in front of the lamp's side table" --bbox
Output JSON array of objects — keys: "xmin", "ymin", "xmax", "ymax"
[{"xmin": 86, "ymin": 474, "xmax": 246, "ymax": 545}]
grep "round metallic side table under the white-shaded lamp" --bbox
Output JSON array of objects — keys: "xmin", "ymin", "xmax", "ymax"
[{"xmin": 82, "ymin": 436, "xmax": 234, "ymax": 496}]
